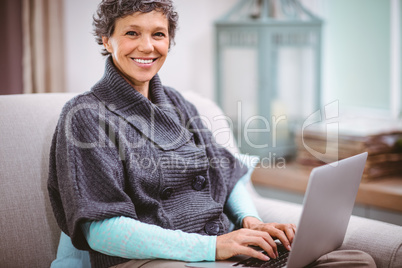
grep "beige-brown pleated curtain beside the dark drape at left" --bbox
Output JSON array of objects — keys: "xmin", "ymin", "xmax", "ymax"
[{"xmin": 22, "ymin": 0, "xmax": 65, "ymax": 93}]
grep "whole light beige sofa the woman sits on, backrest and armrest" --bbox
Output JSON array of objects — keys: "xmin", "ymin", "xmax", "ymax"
[{"xmin": 0, "ymin": 93, "xmax": 402, "ymax": 268}]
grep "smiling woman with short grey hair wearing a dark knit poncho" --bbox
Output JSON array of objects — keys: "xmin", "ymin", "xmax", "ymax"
[{"xmin": 48, "ymin": 0, "xmax": 376, "ymax": 267}]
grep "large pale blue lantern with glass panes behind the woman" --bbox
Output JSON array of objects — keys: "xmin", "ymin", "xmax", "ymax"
[{"xmin": 215, "ymin": 0, "xmax": 322, "ymax": 157}]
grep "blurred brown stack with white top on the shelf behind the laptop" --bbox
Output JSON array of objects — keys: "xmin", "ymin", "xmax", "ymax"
[{"xmin": 295, "ymin": 118, "xmax": 402, "ymax": 181}]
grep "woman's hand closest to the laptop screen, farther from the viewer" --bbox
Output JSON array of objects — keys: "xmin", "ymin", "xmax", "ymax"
[{"xmin": 243, "ymin": 217, "xmax": 296, "ymax": 254}]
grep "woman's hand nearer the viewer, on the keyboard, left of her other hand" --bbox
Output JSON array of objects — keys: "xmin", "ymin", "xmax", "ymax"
[{"xmin": 216, "ymin": 228, "xmax": 278, "ymax": 261}]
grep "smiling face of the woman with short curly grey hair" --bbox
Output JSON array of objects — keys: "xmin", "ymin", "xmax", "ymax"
[{"xmin": 102, "ymin": 11, "xmax": 169, "ymax": 97}]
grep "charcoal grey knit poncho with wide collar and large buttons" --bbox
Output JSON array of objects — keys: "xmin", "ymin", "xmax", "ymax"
[{"xmin": 48, "ymin": 57, "xmax": 247, "ymax": 267}]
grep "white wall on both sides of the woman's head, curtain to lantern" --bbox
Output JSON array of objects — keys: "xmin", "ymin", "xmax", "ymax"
[{"xmin": 64, "ymin": 0, "xmax": 237, "ymax": 98}]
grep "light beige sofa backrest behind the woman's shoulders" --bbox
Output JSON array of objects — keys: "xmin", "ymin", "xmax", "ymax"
[{"xmin": 0, "ymin": 92, "xmax": 237, "ymax": 268}]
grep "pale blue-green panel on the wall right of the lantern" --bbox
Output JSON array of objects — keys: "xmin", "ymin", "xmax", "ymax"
[{"xmin": 323, "ymin": 0, "xmax": 390, "ymax": 109}]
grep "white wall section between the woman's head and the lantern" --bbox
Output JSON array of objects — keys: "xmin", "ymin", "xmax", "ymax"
[{"xmin": 160, "ymin": 0, "xmax": 238, "ymax": 99}]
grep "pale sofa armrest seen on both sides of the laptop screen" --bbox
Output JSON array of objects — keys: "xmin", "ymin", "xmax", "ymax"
[{"xmin": 248, "ymin": 184, "xmax": 402, "ymax": 267}]
